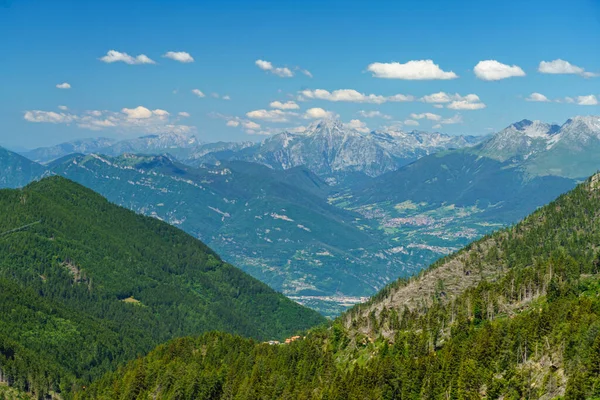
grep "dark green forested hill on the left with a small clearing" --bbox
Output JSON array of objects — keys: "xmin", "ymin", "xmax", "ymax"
[{"xmin": 0, "ymin": 177, "xmax": 324, "ymax": 396}]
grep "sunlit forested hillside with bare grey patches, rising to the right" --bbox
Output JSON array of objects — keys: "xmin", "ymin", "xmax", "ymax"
[{"xmin": 80, "ymin": 175, "xmax": 600, "ymax": 399}]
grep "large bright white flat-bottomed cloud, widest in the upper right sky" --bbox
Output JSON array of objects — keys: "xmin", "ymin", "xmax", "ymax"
[{"xmin": 367, "ymin": 60, "xmax": 458, "ymax": 80}]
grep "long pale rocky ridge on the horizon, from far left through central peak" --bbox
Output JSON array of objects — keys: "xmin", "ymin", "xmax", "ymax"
[{"xmin": 24, "ymin": 119, "xmax": 482, "ymax": 177}]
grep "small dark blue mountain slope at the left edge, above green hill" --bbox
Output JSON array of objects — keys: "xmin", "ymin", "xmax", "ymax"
[{"xmin": 0, "ymin": 147, "xmax": 47, "ymax": 188}]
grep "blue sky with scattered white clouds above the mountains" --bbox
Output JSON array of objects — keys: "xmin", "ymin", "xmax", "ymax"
[{"xmin": 0, "ymin": 0, "xmax": 600, "ymax": 148}]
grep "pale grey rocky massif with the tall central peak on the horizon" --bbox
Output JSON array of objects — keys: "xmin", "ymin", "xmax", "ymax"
[{"xmin": 186, "ymin": 119, "xmax": 480, "ymax": 176}]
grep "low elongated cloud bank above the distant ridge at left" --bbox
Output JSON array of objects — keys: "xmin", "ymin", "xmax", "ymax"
[{"xmin": 24, "ymin": 106, "xmax": 195, "ymax": 134}]
